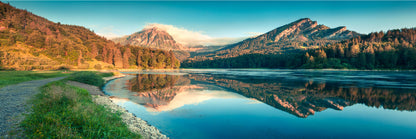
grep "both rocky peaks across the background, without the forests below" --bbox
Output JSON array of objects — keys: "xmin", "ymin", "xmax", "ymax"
[{"xmin": 112, "ymin": 18, "xmax": 360, "ymax": 61}]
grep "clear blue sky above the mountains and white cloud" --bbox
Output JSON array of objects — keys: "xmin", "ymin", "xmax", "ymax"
[{"xmin": 4, "ymin": 1, "xmax": 416, "ymax": 38}]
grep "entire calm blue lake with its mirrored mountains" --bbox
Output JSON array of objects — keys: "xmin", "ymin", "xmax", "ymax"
[{"xmin": 104, "ymin": 69, "xmax": 416, "ymax": 139}]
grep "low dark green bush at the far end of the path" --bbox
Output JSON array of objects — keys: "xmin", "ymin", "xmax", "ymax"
[{"xmin": 68, "ymin": 71, "xmax": 104, "ymax": 87}]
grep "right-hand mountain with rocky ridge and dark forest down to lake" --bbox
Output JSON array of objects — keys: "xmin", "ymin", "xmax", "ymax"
[{"xmin": 181, "ymin": 18, "xmax": 416, "ymax": 69}]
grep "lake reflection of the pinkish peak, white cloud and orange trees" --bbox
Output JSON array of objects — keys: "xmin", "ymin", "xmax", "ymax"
[{"xmin": 119, "ymin": 74, "xmax": 244, "ymax": 112}]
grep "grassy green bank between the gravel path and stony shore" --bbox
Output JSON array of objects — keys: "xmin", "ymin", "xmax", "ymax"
[{"xmin": 21, "ymin": 81, "xmax": 140, "ymax": 138}]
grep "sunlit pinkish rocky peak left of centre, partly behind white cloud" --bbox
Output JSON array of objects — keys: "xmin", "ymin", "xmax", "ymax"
[{"xmin": 113, "ymin": 27, "xmax": 182, "ymax": 50}]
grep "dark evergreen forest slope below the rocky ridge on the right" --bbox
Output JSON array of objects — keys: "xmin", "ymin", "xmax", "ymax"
[{"xmin": 182, "ymin": 28, "xmax": 416, "ymax": 69}]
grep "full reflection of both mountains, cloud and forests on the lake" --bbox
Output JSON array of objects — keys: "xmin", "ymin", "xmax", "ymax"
[{"xmin": 119, "ymin": 74, "xmax": 416, "ymax": 118}]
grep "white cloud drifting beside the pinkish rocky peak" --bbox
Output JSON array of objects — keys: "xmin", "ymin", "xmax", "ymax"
[{"xmin": 144, "ymin": 23, "xmax": 245, "ymax": 46}]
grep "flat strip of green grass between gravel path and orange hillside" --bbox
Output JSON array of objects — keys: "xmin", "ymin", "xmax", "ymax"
[{"xmin": 0, "ymin": 71, "xmax": 69, "ymax": 88}]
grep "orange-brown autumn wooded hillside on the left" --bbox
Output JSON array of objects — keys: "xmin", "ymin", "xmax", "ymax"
[{"xmin": 0, "ymin": 2, "xmax": 179, "ymax": 70}]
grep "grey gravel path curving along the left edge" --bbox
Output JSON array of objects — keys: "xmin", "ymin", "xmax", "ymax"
[{"xmin": 0, "ymin": 77, "xmax": 65, "ymax": 138}]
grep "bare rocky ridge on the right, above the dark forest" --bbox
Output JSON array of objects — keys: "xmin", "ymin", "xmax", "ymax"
[{"xmin": 190, "ymin": 18, "xmax": 360, "ymax": 59}]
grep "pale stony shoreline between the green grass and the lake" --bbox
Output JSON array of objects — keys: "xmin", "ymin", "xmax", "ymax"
[{"xmin": 67, "ymin": 74, "xmax": 169, "ymax": 139}]
